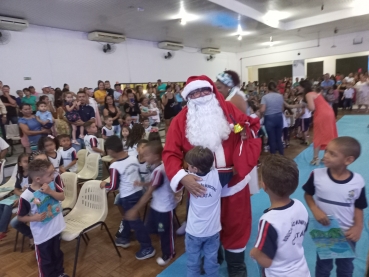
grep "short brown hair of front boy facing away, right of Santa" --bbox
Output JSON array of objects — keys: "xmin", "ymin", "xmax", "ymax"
[{"xmin": 261, "ymin": 155, "xmax": 299, "ymax": 197}]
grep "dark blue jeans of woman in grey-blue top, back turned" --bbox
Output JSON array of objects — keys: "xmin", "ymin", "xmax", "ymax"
[{"xmin": 264, "ymin": 113, "xmax": 284, "ymax": 155}]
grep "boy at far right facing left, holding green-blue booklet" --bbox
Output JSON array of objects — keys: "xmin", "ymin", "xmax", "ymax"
[{"xmin": 303, "ymin": 137, "xmax": 368, "ymax": 277}]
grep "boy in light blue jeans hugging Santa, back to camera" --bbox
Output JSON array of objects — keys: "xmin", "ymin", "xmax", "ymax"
[{"xmin": 185, "ymin": 146, "xmax": 222, "ymax": 277}]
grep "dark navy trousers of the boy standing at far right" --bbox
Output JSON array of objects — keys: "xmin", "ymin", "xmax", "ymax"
[{"xmin": 315, "ymin": 242, "xmax": 356, "ymax": 277}]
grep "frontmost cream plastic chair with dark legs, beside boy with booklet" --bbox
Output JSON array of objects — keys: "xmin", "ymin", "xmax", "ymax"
[{"xmin": 61, "ymin": 180, "xmax": 121, "ymax": 276}]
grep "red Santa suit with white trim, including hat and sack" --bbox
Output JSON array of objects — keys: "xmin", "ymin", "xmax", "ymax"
[{"xmin": 163, "ymin": 76, "xmax": 261, "ymax": 252}]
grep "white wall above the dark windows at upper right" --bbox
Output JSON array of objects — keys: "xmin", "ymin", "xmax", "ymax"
[{"xmin": 237, "ymin": 31, "xmax": 369, "ymax": 81}]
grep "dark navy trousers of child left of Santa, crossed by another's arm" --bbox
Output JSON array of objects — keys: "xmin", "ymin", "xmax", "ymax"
[{"xmin": 113, "ymin": 190, "xmax": 152, "ymax": 249}]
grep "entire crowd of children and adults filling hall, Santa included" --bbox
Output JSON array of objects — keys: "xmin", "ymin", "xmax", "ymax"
[{"xmin": 0, "ymin": 70, "xmax": 369, "ymax": 277}]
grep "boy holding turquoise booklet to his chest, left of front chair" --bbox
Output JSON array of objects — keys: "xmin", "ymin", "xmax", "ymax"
[{"xmin": 18, "ymin": 159, "xmax": 68, "ymax": 277}]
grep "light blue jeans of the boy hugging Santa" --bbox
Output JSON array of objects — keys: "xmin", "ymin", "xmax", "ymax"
[{"xmin": 185, "ymin": 233, "xmax": 220, "ymax": 277}]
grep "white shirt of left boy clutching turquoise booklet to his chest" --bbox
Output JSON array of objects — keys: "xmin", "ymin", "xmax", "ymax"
[{"xmin": 18, "ymin": 183, "xmax": 65, "ymax": 245}]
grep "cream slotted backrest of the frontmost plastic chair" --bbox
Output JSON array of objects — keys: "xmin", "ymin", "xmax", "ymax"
[{"xmin": 65, "ymin": 180, "xmax": 108, "ymax": 222}]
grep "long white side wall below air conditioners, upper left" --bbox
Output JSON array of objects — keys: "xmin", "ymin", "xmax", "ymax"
[{"xmin": 0, "ymin": 26, "xmax": 240, "ymax": 92}]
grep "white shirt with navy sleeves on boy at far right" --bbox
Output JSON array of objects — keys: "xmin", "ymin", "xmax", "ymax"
[{"xmin": 302, "ymin": 168, "xmax": 368, "ymax": 231}]
